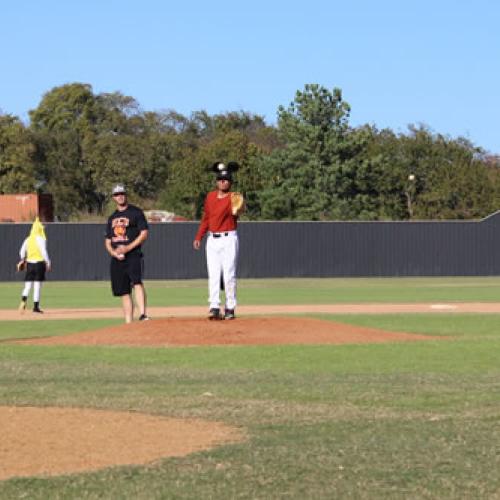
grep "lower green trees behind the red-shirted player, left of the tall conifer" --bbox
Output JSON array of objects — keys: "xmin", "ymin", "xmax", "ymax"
[{"xmin": 159, "ymin": 111, "xmax": 273, "ymax": 219}]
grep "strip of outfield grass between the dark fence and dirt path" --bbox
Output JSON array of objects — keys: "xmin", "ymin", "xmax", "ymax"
[{"xmin": 0, "ymin": 277, "xmax": 500, "ymax": 309}]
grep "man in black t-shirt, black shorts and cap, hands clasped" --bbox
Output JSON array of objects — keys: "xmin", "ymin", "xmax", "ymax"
[{"xmin": 105, "ymin": 184, "xmax": 149, "ymax": 323}]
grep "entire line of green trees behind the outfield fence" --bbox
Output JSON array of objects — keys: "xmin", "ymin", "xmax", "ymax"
[{"xmin": 0, "ymin": 83, "xmax": 500, "ymax": 220}]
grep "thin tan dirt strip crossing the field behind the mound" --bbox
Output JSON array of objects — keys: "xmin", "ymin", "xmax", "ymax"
[{"xmin": 0, "ymin": 302, "xmax": 500, "ymax": 321}]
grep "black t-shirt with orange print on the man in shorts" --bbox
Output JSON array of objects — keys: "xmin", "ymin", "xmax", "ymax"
[{"xmin": 106, "ymin": 205, "xmax": 148, "ymax": 255}]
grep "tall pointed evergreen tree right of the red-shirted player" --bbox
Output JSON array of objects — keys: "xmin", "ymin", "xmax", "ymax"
[{"xmin": 259, "ymin": 84, "xmax": 378, "ymax": 220}]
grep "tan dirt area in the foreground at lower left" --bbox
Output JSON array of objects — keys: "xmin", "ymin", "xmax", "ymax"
[{"xmin": 0, "ymin": 407, "xmax": 244, "ymax": 480}]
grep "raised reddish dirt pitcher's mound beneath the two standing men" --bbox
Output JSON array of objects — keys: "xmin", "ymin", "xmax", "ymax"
[{"xmin": 23, "ymin": 317, "xmax": 432, "ymax": 346}]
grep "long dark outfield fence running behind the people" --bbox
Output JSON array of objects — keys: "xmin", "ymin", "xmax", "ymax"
[{"xmin": 0, "ymin": 212, "xmax": 500, "ymax": 281}]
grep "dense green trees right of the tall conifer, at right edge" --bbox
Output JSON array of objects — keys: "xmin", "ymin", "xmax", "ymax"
[{"xmin": 369, "ymin": 125, "xmax": 498, "ymax": 219}]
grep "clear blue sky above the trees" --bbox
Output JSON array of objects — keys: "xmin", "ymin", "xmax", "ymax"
[{"xmin": 0, "ymin": 0, "xmax": 500, "ymax": 154}]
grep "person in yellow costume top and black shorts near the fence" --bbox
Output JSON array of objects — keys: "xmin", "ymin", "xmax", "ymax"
[{"xmin": 18, "ymin": 217, "xmax": 51, "ymax": 313}]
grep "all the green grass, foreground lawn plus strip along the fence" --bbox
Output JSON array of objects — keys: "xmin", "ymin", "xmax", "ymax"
[{"xmin": 0, "ymin": 278, "xmax": 500, "ymax": 499}]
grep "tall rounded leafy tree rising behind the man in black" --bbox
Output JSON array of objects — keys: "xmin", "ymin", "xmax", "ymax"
[{"xmin": 30, "ymin": 83, "xmax": 172, "ymax": 218}]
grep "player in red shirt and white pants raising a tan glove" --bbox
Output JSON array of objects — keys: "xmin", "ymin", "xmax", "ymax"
[{"xmin": 193, "ymin": 162, "xmax": 243, "ymax": 320}]
